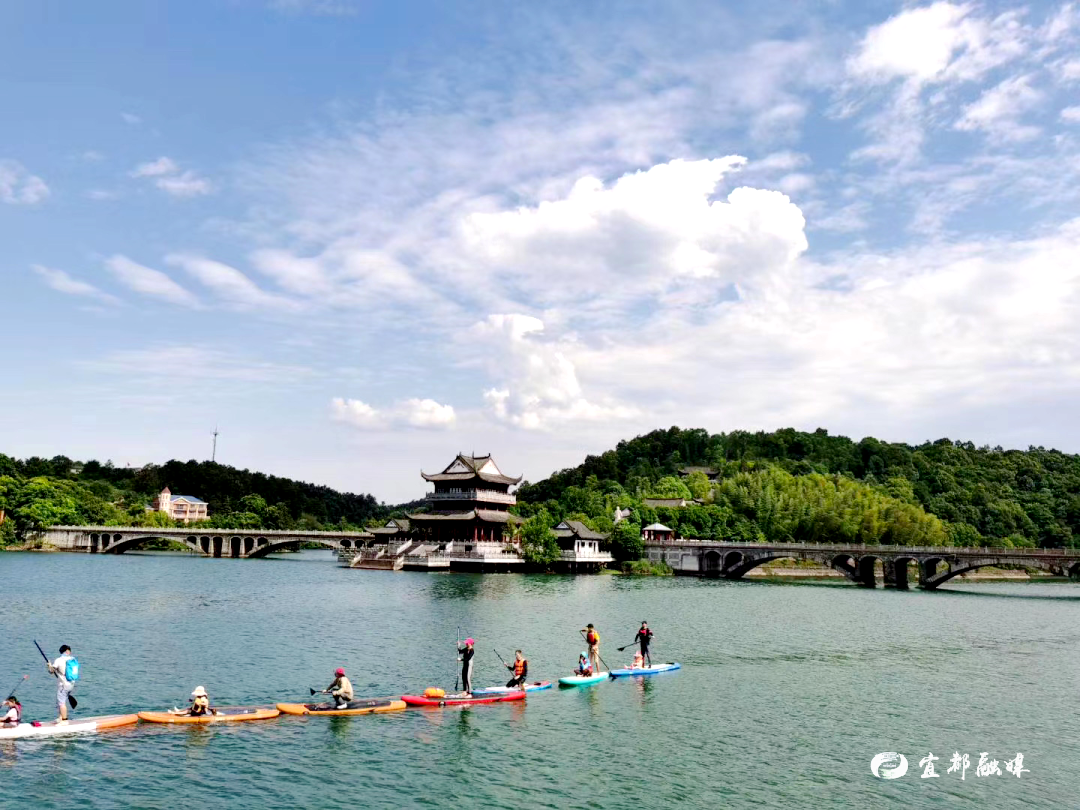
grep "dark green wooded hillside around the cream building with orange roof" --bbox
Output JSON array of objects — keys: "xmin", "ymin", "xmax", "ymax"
[{"xmin": 0, "ymin": 455, "xmax": 389, "ymax": 544}]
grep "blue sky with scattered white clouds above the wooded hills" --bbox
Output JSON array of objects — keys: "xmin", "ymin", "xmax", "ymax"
[{"xmin": 0, "ymin": 0, "xmax": 1080, "ymax": 501}]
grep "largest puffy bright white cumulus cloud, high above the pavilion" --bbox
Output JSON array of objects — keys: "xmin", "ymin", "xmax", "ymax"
[{"xmin": 462, "ymin": 156, "xmax": 807, "ymax": 302}]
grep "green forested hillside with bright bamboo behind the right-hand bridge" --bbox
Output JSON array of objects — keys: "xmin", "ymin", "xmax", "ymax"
[{"xmin": 518, "ymin": 428, "xmax": 1080, "ymax": 548}]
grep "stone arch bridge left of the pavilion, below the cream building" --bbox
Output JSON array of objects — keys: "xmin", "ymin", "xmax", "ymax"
[{"xmin": 36, "ymin": 526, "xmax": 372, "ymax": 558}]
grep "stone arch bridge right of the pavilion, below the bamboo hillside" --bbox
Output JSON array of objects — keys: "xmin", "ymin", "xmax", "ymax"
[{"xmin": 645, "ymin": 540, "xmax": 1080, "ymax": 591}]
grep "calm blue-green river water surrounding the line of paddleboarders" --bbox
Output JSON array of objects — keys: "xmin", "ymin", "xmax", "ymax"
[{"xmin": 0, "ymin": 552, "xmax": 1080, "ymax": 810}]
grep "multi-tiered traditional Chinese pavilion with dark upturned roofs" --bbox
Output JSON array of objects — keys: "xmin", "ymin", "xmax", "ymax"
[{"xmin": 408, "ymin": 455, "xmax": 522, "ymax": 554}]
